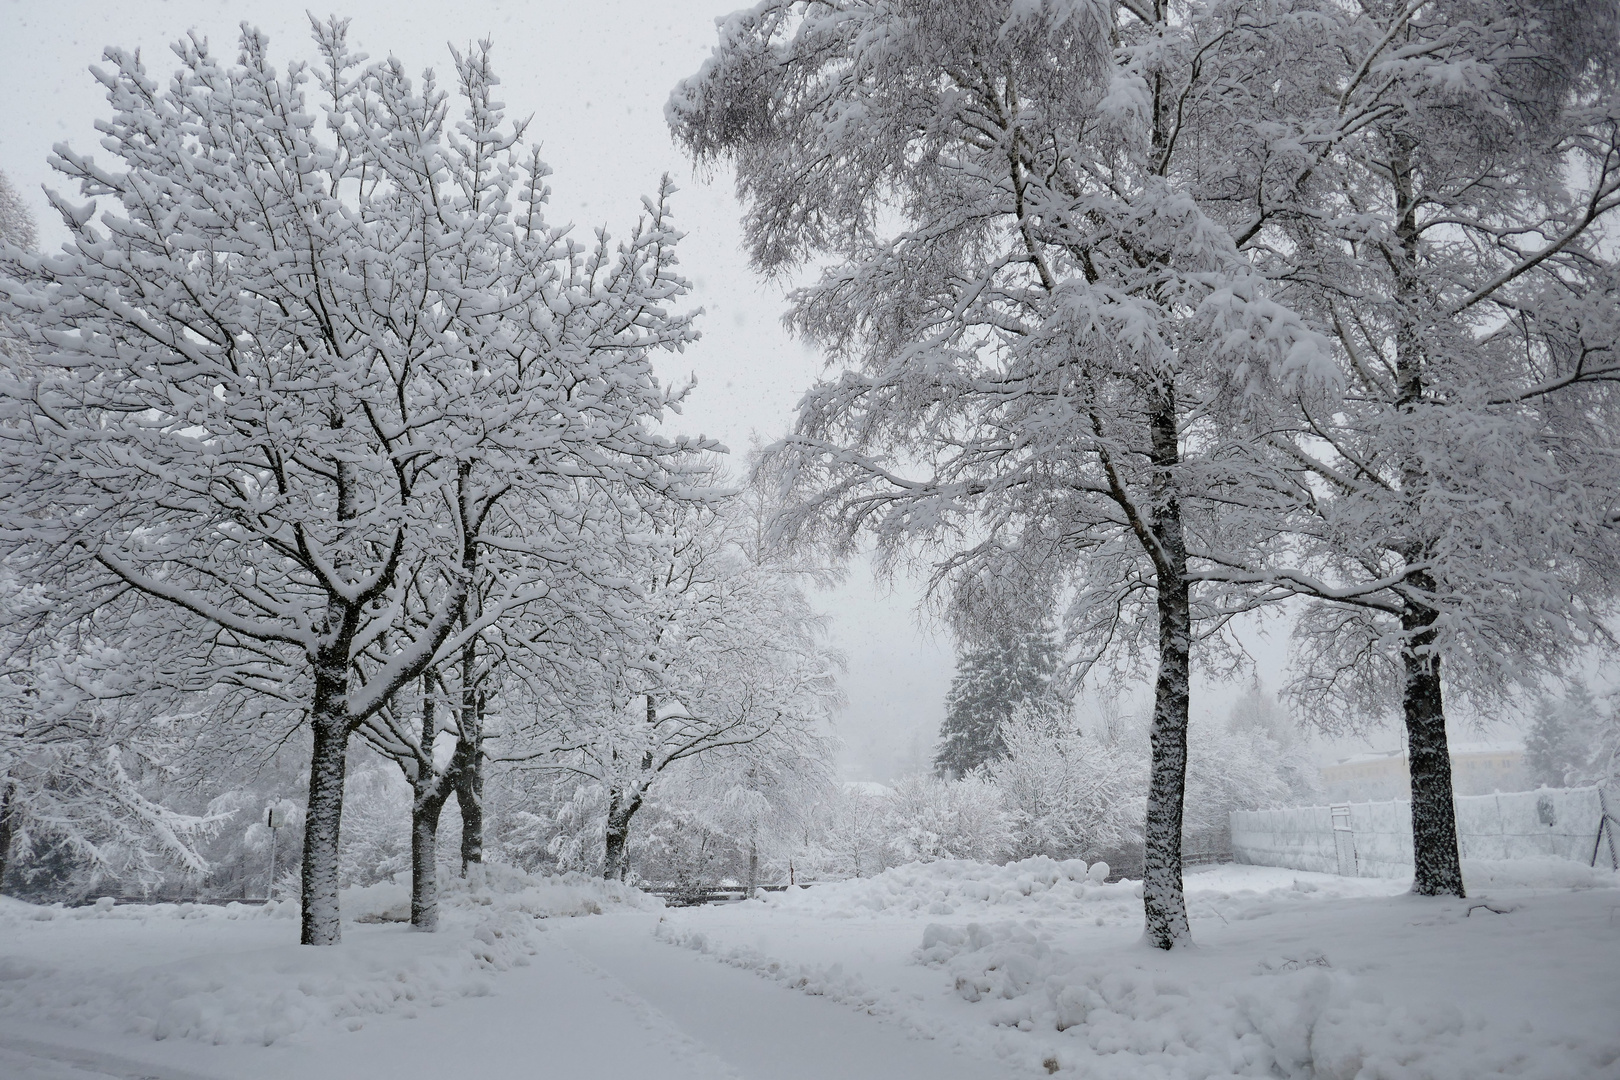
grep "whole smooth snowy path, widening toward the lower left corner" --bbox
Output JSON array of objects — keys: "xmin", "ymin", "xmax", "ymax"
[{"xmin": 0, "ymin": 912, "xmax": 1003, "ymax": 1080}]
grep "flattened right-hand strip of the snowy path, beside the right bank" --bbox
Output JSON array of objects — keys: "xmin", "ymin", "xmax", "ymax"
[{"xmin": 554, "ymin": 915, "xmax": 1009, "ymax": 1080}]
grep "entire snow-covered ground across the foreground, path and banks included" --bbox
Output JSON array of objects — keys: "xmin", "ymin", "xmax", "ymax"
[{"xmin": 0, "ymin": 860, "xmax": 1620, "ymax": 1080}]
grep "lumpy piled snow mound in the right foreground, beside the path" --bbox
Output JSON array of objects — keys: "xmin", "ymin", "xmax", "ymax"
[{"xmin": 914, "ymin": 921, "xmax": 1620, "ymax": 1080}]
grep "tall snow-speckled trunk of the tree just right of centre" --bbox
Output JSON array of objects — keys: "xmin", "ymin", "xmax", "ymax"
[{"xmin": 1142, "ymin": 392, "xmax": 1192, "ymax": 949}]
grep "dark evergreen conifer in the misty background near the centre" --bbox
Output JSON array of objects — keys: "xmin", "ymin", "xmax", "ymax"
[{"xmin": 933, "ymin": 628, "xmax": 1064, "ymax": 776}]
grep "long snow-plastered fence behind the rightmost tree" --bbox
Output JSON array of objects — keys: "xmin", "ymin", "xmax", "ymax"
[{"xmin": 1231, "ymin": 787, "xmax": 1620, "ymax": 878}]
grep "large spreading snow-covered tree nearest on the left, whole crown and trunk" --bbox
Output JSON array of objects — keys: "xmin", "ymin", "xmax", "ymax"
[{"xmin": 0, "ymin": 19, "xmax": 692, "ymax": 944}]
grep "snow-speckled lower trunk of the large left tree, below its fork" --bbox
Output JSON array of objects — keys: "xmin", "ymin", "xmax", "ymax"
[{"xmin": 298, "ymin": 693, "xmax": 348, "ymax": 946}]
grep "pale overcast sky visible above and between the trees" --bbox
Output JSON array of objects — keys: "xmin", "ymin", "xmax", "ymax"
[{"xmin": 0, "ymin": 0, "xmax": 1490, "ymax": 780}]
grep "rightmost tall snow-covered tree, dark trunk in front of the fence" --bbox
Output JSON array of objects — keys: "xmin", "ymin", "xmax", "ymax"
[{"xmin": 1244, "ymin": 0, "xmax": 1620, "ymax": 895}]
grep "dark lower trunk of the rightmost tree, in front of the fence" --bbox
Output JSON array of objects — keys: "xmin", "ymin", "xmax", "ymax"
[{"xmin": 1401, "ymin": 599, "xmax": 1464, "ymax": 897}]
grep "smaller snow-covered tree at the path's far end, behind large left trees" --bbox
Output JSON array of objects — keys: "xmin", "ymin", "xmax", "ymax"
[{"xmin": 548, "ymin": 488, "xmax": 841, "ymax": 879}]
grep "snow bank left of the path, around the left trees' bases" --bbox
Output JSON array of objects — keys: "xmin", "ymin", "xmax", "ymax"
[{"xmin": 0, "ymin": 866, "xmax": 661, "ymax": 1044}]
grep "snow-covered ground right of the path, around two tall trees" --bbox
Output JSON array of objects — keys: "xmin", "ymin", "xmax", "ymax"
[{"xmin": 659, "ymin": 860, "xmax": 1620, "ymax": 1080}]
